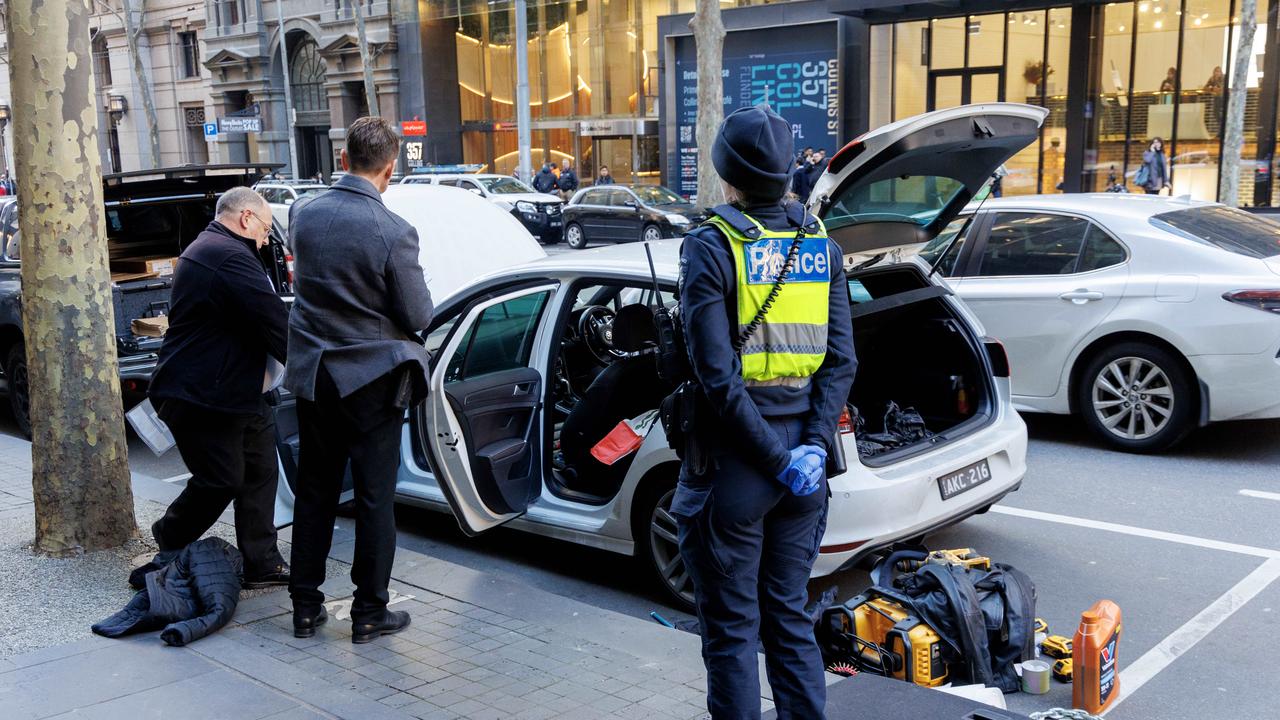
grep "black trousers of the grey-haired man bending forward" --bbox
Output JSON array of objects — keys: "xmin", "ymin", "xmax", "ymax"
[{"xmin": 151, "ymin": 400, "xmax": 284, "ymax": 578}]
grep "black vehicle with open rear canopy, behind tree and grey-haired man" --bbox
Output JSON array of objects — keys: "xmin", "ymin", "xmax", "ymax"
[{"xmin": 0, "ymin": 164, "xmax": 293, "ymax": 437}]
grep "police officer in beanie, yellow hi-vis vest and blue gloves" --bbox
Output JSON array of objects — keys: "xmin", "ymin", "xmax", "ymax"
[{"xmin": 672, "ymin": 105, "xmax": 856, "ymax": 720}]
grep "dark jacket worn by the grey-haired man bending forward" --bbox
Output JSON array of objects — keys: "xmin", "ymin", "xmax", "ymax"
[{"xmin": 150, "ymin": 222, "xmax": 289, "ymax": 414}]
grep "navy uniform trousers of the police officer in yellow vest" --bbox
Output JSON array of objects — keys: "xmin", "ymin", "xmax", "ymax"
[{"xmin": 671, "ymin": 418, "xmax": 827, "ymax": 720}]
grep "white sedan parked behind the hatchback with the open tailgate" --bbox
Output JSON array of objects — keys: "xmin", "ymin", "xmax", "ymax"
[{"xmin": 922, "ymin": 193, "xmax": 1280, "ymax": 452}]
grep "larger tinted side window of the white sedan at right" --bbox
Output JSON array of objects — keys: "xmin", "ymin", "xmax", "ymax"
[{"xmin": 978, "ymin": 213, "xmax": 1089, "ymax": 277}]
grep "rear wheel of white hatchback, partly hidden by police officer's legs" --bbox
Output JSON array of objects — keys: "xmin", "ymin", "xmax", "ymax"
[{"xmin": 631, "ymin": 473, "xmax": 694, "ymax": 612}]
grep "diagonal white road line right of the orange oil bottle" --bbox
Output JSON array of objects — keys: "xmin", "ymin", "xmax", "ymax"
[{"xmin": 1103, "ymin": 557, "xmax": 1280, "ymax": 715}]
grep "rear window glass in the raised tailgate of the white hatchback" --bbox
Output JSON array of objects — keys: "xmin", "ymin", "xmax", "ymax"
[{"xmin": 823, "ymin": 174, "xmax": 965, "ymax": 229}]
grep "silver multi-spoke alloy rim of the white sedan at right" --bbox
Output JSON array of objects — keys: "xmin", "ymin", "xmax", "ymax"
[{"xmin": 1092, "ymin": 357, "xmax": 1174, "ymax": 439}]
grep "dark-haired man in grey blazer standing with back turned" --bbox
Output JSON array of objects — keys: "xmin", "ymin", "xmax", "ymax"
[{"xmin": 285, "ymin": 118, "xmax": 431, "ymax": 643}]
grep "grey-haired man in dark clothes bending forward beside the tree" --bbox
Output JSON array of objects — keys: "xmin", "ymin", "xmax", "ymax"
[{"xmin": 150, "ymin": 187, "xmax": 289, "ymax": 588}]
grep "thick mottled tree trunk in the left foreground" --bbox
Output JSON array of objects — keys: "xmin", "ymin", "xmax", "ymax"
[{"xmin": 8, "ymin": 0, "xmax": 137, "ymax": 555}]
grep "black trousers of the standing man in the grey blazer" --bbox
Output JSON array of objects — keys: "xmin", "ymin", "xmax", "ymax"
[{"xmin": 289, "ymin": 366, "xmax": 404, "ymax": 623}]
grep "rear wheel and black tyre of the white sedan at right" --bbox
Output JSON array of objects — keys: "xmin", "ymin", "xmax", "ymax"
[{"xmin": 1075, "ymin": 342, "xmax": 1197, "ymax": 452}]
